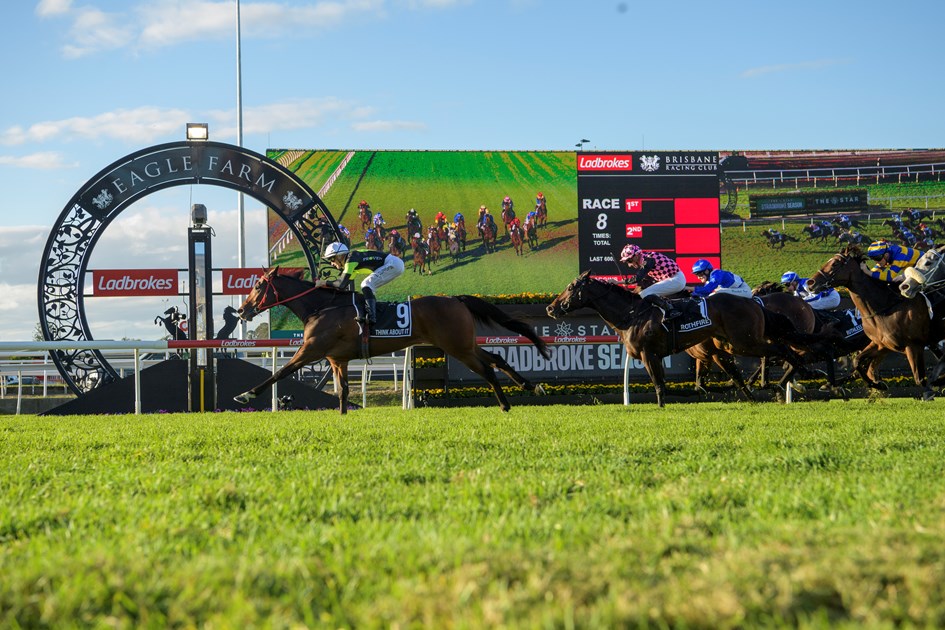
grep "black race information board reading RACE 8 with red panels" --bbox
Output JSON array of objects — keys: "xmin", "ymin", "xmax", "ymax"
[{"xmin": 577, "ymin": 151, "xmax": 721, "ymax": 282}]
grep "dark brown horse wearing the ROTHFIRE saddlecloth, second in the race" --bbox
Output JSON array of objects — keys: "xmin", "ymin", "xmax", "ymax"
[{"xmin": 547, "ymin": 271, "xmax": 809, "ymax": 407}]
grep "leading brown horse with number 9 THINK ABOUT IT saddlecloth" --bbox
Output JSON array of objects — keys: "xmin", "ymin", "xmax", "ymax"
[{"xmin": 235, "ymin": 267, "xmax": 550, "ymax": 414}]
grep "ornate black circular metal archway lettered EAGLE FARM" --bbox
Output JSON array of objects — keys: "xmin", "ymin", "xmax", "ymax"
[{"xmin": 38, "ymin": 141, "xmax": 340, "ymax": 394}]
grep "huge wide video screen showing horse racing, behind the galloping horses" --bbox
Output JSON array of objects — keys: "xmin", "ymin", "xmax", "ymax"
[{"xmin": 267, "ymin": 149, "xmax": 945, "ymax": 336}]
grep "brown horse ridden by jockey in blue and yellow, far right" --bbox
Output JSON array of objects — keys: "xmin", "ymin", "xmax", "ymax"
[{"xmin": 809, "ymin": 246, "xmax": 945, "ymax": 400}]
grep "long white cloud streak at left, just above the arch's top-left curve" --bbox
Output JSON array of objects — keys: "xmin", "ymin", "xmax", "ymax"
[{"xmin": 0, "ymin": 106, "xmax": 191, "ymax": 146}]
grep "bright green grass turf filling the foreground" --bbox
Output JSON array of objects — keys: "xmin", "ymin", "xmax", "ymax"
[{"xmin": 0, "ymin": 399, "xmax": 945, "ymax": 628}]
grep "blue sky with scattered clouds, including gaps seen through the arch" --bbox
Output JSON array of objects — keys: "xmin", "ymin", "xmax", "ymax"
[{"xmin": 0, "ymin": 0, "xmax": 945, "ymax": 340}]
